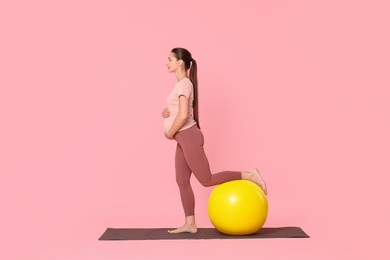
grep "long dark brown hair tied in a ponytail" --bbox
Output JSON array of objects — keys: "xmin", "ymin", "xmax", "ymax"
[{"xmin": 171, "ymin": 48, "xmax": 200, "ymax": 128}]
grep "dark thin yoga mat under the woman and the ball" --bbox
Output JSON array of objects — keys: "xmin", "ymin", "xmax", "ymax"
[{"xmin": 99, "ymin": 227, "xmax": 309, "ymax": 240}]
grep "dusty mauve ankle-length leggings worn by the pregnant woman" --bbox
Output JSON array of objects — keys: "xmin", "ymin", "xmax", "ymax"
[{"xmin": 175, "ymin": 125, "xmax": 241, "ymax": 216}]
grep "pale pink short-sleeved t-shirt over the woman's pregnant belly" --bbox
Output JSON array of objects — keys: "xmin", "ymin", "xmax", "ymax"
[{"xmin": 164, "ymin": 78, "xmax": 196, "ymax": 132}]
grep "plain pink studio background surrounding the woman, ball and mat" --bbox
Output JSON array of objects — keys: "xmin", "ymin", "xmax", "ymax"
[{"xmin": 0, "ymin": 0, "xmax": 390, "ymax": 260}]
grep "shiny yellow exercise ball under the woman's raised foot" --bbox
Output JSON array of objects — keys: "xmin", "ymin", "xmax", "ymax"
[{"xmin": 208, "ymin": 180, "xmax": 268, "ymax": 235}]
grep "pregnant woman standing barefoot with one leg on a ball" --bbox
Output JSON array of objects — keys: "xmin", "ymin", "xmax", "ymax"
[{"xmin": 162, "ymin": 48, "xmax": 267, "ymax": 233}]
